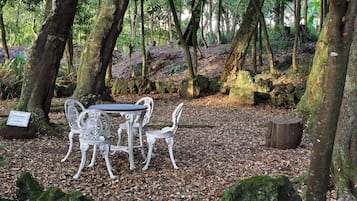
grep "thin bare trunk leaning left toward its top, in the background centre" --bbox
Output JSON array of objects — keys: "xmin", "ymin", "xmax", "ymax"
[{"xmin": 169, "ymin": 0, "xmax": 195, "ymax": 79}]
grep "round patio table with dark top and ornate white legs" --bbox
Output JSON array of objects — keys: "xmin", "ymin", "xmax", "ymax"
[{"xmin": 89, "ymin": 103, "xmax": 147, "ymax": 170}]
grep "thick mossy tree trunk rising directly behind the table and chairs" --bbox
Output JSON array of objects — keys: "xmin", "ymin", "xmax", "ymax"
[{"xmin": 73, "ymin": 0, "xmax": 129, "ymax": 104}]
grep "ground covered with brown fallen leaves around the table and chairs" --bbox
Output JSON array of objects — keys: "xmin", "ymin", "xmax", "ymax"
[{"xmin": 0, "ymin": 94, "xmax": 312, "ymax": 201}]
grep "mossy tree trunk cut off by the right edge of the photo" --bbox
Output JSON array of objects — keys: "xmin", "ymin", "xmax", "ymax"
[{"xmin": 332, "ymin": 14, "xmax": 357, "ymax": 200}]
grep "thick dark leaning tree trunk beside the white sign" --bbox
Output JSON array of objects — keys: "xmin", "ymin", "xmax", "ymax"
[{"xmin": 16, "ymin": 0, "xmax": 77, "ymax": 134}]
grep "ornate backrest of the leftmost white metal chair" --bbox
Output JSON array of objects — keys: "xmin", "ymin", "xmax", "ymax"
[{"xmin": 64, "ymin": 99, "xmax": 85, "ymax": 129}]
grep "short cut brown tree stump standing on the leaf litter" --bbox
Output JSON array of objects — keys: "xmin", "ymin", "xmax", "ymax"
[{"xmin": 265, "ymin": 115, "xmax": 303, "ymax": 149}]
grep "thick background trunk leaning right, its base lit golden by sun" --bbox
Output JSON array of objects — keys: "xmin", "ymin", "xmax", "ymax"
[{"xmin": 221, "ymin": 0, "xmax": 264, "ymax": 90}]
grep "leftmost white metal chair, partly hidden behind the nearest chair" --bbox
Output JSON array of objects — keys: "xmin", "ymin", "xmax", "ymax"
[{"xmin": 61, "ymin": 99, "xmax": 85, "ymax": 162}]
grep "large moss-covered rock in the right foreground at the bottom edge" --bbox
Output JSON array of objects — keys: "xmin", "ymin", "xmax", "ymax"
[{"xmin": 221, "ymin": 175, "xmax": 301, "ymax": 201}]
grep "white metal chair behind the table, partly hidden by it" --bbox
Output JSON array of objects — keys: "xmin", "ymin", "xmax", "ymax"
[{"xmin": 117, "ymin": 97, "xmax": 154, "ymax": 158}]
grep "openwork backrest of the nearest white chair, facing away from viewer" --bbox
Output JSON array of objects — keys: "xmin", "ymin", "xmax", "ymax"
[{"xmin": 78, "ymin": 109, "xmax": 112, "ymax": 141}]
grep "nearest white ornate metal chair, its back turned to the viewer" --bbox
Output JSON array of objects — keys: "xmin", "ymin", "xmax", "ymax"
[{"xmin": 73, "ymin": 109, "xmax": 116, "ymax": 179}]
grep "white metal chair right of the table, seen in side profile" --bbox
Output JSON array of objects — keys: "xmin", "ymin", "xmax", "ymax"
[{"xmin": 143, "ymin": 103, "xmax": 183, "ymax": 170}]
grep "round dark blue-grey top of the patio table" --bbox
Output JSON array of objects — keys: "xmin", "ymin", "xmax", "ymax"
[{"xmin": 89, "ymin": 103, "xmax": 147, "ymax": 112}]
